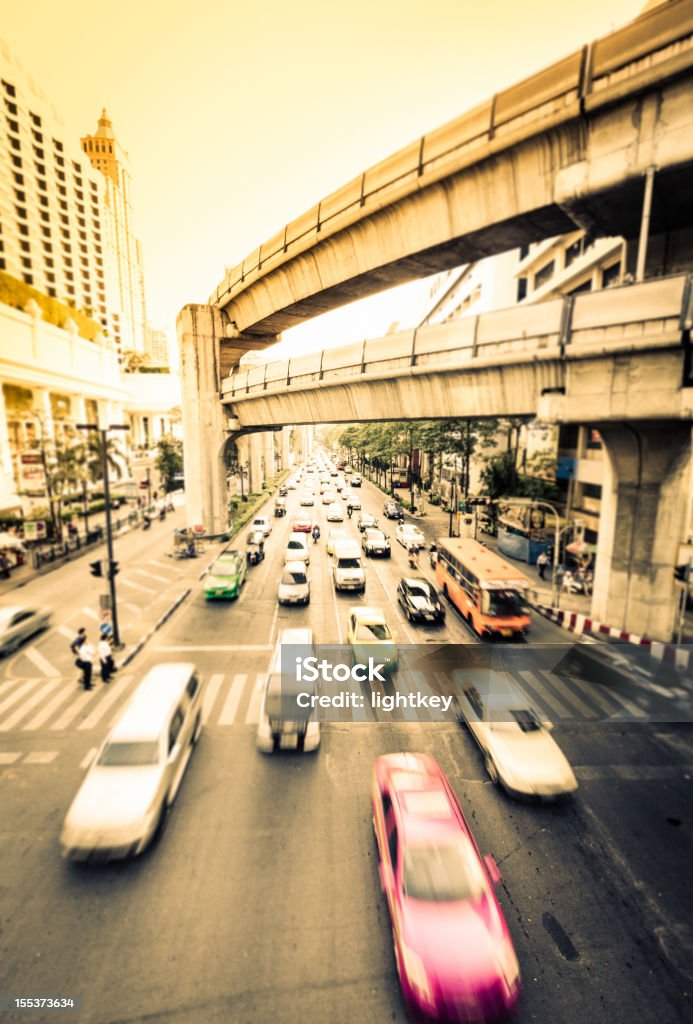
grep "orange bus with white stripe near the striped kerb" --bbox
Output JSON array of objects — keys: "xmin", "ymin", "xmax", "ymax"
[{"xmin": 435, "ymin": 538, "xmax": 531, "ymax": 640}]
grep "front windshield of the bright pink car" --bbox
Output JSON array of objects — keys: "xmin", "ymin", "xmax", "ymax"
[{"xmin": 402, "ymin": 840, "xmax": 485, "ymax": 902}]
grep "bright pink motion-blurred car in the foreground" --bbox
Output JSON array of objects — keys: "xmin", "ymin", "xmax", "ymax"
[{"xmin": 371, "ymin": 754, "xmax": 520, "ymax": 1022}]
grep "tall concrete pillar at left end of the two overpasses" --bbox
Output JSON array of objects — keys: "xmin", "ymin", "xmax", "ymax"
[{"xmin": 176, "ymin": 305, "xmax": 228, "ymax": 534}]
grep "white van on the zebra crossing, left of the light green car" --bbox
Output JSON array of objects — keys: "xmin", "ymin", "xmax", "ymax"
[{"xmin": 256, "ymin": 629, "xmax": 320, "ymax": 754}]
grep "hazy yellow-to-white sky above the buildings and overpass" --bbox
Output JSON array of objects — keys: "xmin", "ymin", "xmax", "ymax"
[{"xmin": 0, "ymin": 0, "xmax": 645, "ymax": 358}]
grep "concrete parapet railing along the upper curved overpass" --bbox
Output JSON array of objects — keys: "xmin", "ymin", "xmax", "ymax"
[{"xmin": 210, "ymin": 0, "xmax": 693, "ymax": 306}]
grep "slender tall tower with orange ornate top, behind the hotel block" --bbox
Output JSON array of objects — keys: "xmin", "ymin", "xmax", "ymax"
[{"xmin": 82, "ymin": 110, "xmax": 146, "ymax": 352}]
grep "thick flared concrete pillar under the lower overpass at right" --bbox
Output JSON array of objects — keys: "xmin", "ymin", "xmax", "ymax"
[{"xmin": 592, "ymin": 421, "xmax": 691, "ymax": 642}]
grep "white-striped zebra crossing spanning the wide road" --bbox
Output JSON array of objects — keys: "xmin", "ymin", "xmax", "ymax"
[{"xmin": 0, "ymin": 655, "xmax": 648, "ymax": 738}]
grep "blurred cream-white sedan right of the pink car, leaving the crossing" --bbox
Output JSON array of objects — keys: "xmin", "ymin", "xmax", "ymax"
[{"xmin": 458, "ymin": 673, "xmax": 577, "ymax": 799}]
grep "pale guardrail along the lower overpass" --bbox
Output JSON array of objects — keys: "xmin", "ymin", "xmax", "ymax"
[{"xmin": 222, "ymin": 274, "xmax": 693, "ymax": 401}]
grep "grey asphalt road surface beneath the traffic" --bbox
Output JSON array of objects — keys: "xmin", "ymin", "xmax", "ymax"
[{"xmin": 0, "ymin": 475, "xmax": 693, "ymax": 1024}]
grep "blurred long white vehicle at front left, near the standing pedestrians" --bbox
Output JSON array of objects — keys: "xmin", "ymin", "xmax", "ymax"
[{"xmin": 60, "ymin": 663, "xmax": 203, "ymax": 860}]
